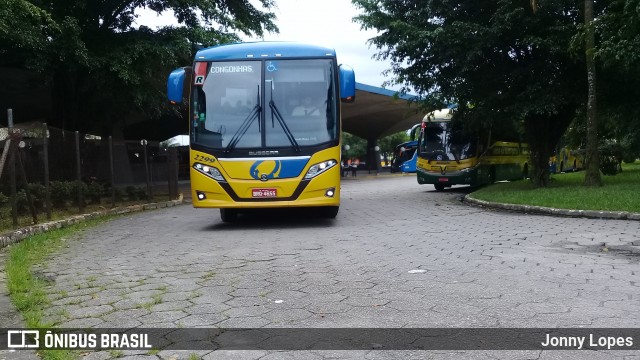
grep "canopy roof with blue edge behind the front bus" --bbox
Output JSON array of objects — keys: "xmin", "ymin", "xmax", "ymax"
[{"xmin": 342, "ymin": 83, "xmax": 424, "ymax": 140}]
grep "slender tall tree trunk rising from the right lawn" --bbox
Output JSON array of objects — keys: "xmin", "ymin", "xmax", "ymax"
[{"xmin": 584, "ymin": 0, "xmax": 602, "ymax": 186}]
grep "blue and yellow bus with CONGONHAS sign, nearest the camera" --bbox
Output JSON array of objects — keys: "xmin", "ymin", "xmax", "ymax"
[{"xmin": 167, "ymin": 42, "xmax": 355, "ymax": 222}]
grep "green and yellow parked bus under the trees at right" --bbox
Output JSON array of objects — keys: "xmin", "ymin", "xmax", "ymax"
[{"xmin": 416, "ymin": 109, "xmax": 529, "ymax": 191}]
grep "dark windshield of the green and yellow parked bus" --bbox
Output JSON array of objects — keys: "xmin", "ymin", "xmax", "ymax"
[{"xmin": 420, "ymin": 121, "xmax": 476, "ymax": 161}]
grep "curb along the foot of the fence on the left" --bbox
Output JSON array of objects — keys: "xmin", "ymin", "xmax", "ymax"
[{"xmin": 0, "ymin": 195, "xmax": 184, "ymax": 249}]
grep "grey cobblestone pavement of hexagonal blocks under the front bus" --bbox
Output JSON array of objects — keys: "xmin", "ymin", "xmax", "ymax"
[{"xmin": 3, "ymin": 176, "xmax": 640, "ymax": 359}]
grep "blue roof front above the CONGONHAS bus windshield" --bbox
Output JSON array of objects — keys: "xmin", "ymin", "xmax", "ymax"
[{"xmin": 196, "ymin": 41, "xmax": 336, "ymax": 61}]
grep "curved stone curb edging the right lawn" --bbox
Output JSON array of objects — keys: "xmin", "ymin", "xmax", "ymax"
[{"xmin": 462, "ymin": 195, "xmax": 640, "ymax": 221}]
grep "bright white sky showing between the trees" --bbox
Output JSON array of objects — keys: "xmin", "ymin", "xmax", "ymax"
[{"xmin": 137, "ymin": 0, "xmax": 400, "ymax": 90}]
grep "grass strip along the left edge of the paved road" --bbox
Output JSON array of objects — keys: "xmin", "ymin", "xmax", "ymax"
[{"xmin": 5, "ymin": 217, "xmax": 108, "ymax": 360}]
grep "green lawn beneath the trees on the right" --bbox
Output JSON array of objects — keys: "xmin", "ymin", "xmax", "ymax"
[{"xmin": 471, "ymin": 161, "xmax": 640, "ymax": 213}]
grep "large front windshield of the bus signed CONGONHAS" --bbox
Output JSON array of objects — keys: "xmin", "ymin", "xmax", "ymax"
[{"xmin": 191, "ymin": 59, "xmax": 339, "ymax": 152}]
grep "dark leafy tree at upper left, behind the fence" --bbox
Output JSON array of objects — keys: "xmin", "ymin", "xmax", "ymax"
[{"xmin": 0, "ymin": 0, "xmax": 277, "ymax": 133}]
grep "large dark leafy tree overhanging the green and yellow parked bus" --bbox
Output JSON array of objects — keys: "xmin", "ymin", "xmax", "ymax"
[{"xmin": 353, "ymin": 0, "xmax": 586, "ymax": 186}]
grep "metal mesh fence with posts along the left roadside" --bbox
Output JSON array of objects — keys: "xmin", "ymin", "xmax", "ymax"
[{"xmin": 0, "ymin": 122, "xmax": 189, "ymax": 225}]
